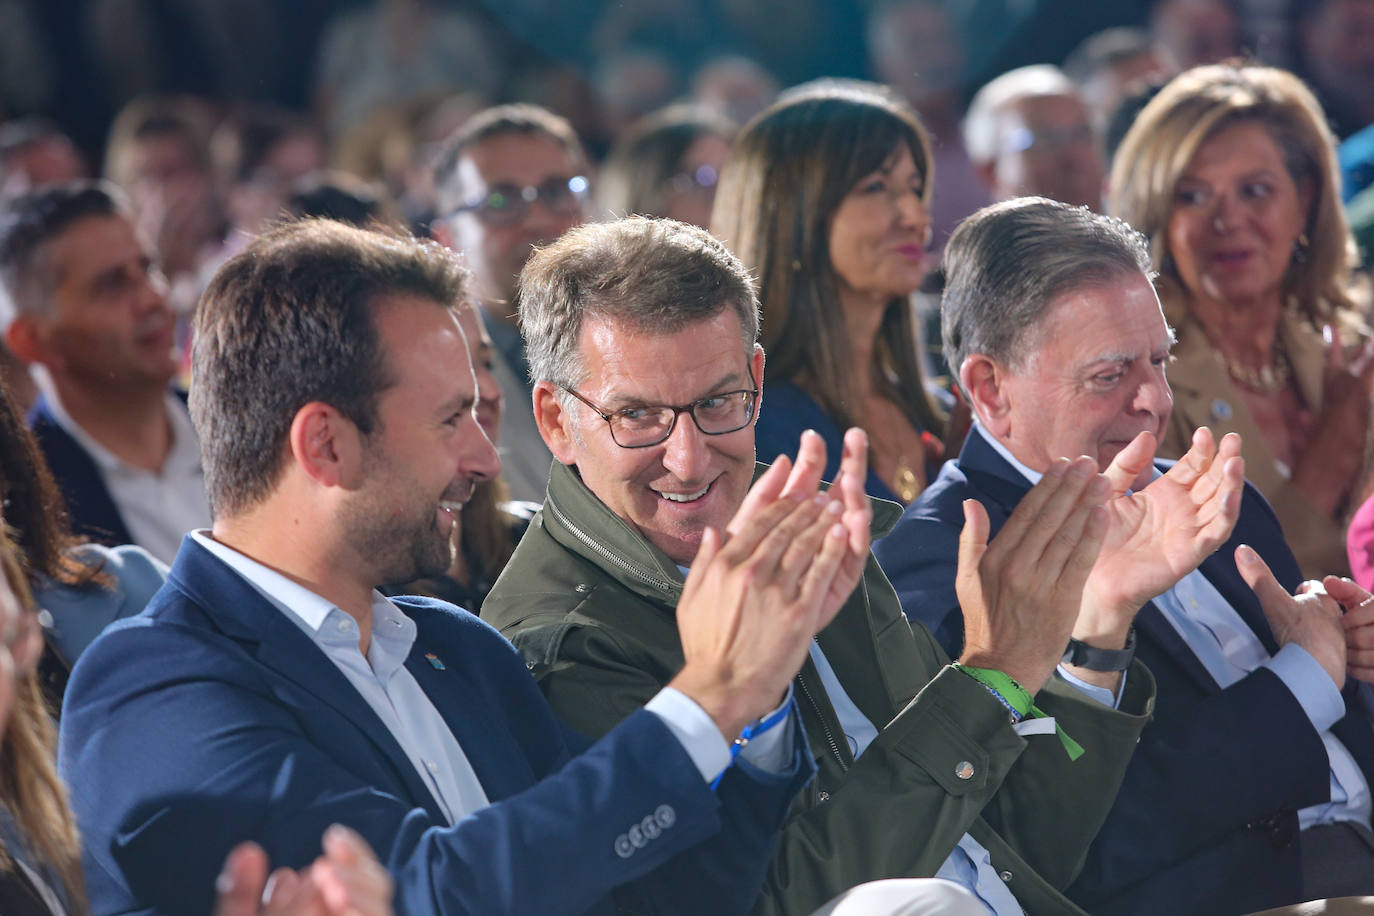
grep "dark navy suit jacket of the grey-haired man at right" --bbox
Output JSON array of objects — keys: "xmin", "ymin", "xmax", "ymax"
[{"xmin": 874, "ymin": 428, "xmax": 1374, "ymax": 915}]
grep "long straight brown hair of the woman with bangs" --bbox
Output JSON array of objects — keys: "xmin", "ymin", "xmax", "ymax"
[{"xmin": 710, "ymin": 80, "xmax": 944, "ymax": 431}]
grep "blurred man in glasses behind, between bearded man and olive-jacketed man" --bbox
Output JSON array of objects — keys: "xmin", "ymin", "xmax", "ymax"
[{"xmin": 430, "ymin": 104, "xmax": 591, "ymax": 501}]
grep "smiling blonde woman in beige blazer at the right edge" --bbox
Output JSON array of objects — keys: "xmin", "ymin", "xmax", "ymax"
[{"xmin": 1112, "ymin": 66, "xmax": 1374, "ymax": 577}]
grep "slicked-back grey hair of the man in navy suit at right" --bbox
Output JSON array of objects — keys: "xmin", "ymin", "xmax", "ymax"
[{"xmin": 941, "ymin": 198, "xmax": 1150, "ymax": 394}]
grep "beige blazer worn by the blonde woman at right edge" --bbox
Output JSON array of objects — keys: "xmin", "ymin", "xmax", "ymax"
[{"xmin": 1158, "ymin": 313, "xmax": 1353, "ymax": 578}]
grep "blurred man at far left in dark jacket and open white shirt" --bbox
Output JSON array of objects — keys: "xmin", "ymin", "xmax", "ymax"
[{"xmin": 0, "ymin": 183, "xmax": 209, "ymax": 562}]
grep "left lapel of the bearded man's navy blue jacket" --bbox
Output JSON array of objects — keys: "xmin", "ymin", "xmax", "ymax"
[{"xmin": 168, "ymin": 534, "xmax": 447, "ymax": 823}]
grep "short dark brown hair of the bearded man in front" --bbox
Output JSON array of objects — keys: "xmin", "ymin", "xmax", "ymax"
[{"xmin": 191, "ymin": 220, "xmax": 466, "ymax": 516}]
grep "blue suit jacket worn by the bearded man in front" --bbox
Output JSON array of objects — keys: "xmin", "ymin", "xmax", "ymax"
[{"xmin": 59, "ymin": 537, "xmax": 812, "ymax": 913}]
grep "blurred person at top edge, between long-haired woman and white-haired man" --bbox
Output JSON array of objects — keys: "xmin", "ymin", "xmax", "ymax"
[{"xmin": 867, "ymin": 0, "xmax": 989, "ymax": 252}]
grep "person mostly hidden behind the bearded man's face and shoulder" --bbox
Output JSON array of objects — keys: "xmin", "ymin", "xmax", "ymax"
[{"xmin": 383, "ymin": 304, "xmax": 539, "ymax": 614}]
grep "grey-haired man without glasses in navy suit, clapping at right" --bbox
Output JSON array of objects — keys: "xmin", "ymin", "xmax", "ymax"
[{"xmin": 875, "ymin": 199, "xmax": 1374, "ymax": 913}]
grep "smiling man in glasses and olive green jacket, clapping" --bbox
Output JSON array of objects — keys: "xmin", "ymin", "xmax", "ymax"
[{"xmin": 482, "ymin": 218, "xmax": 1247, "ymax": 915}]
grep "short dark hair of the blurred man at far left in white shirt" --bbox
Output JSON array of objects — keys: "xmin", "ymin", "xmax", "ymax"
[{"xmin": 0, "ymin": 181, "xmax": 126, "ymax": 328}]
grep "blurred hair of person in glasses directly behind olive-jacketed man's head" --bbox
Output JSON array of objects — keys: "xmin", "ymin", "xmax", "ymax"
[{"xmin": 596, "ymin": 104, "xmax": 735, "ymax": 216}]
